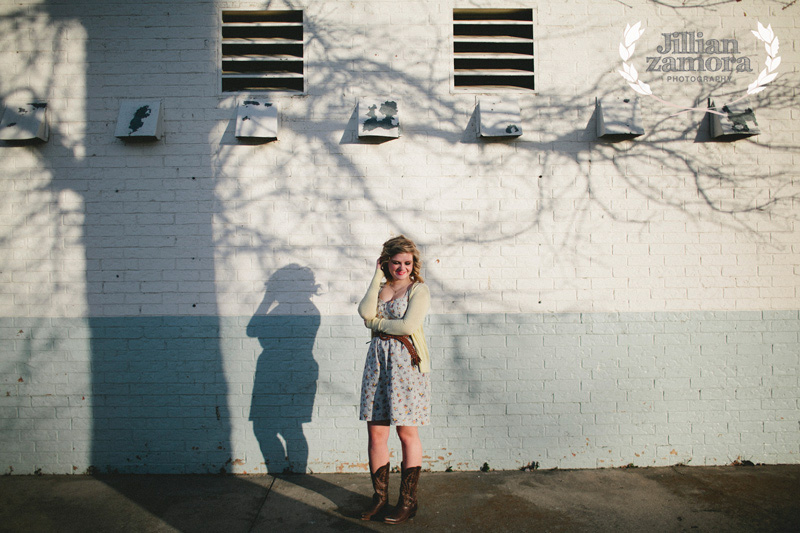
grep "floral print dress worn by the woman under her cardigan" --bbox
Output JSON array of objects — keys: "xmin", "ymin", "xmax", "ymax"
[{"xmin": 360, "ymin": 291, "xmax": 431, "ymax": 426}]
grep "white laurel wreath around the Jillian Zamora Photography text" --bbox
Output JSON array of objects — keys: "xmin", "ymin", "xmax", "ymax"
[{"xmin": 617, "ymin": 21, "xmax": 781, "ymax": 116}]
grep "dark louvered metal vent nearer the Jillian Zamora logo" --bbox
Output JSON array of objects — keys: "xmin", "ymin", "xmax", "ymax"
[{"xmin": 453, "ymin": 9, "xmax": 534, "ymax": 91}]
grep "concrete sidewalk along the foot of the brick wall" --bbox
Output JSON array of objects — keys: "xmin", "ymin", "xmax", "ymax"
[{"xmin": 0, "ymin": 465, "xmax": 800, "ymax": 533}]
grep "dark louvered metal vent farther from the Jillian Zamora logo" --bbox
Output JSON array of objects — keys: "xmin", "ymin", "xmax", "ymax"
[{"xmin": 222, "ymin": 11, "xmax": 305, "ymax": 92}]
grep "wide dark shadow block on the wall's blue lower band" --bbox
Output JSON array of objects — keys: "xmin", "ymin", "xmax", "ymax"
[{"xmin": 87, "ymin": 314, "xmax": 231, "ymax": 473}]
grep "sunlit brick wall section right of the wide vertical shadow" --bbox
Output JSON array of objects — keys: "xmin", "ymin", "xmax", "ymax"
[{"xmin": 209, "ymin": 2, "xmax": 800, "ymax": 471}]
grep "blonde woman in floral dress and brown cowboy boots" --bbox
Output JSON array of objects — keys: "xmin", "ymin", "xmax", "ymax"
[{"xmin": 358, "ymin": 235, "xmax": 431, "ymax": 524}]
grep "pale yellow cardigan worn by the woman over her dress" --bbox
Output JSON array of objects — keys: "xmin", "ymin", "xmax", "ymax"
[{"xmin": 358, "ymin": 269, "xmax": 431, "ymax": 372}]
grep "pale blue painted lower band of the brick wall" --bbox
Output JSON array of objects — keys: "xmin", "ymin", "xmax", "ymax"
[{"xmin": 0, "ymin": 311, "xmax": 800, "ymax": 473}]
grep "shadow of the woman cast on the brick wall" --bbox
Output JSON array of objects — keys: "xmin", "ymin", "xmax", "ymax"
[{"xmin": 252, "ymin": 264, "xmax": 320, "ymax": 474}]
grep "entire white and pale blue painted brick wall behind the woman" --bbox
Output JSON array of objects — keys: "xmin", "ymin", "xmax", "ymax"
[{"xmin": 0, "ymin": 0, "xmax": 800, "ymax": 473}]
